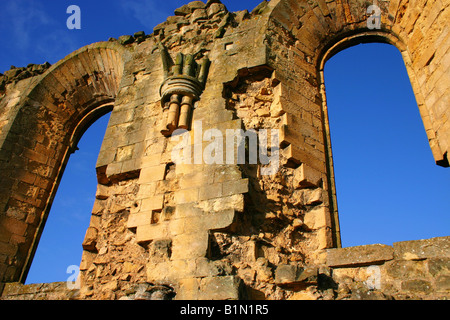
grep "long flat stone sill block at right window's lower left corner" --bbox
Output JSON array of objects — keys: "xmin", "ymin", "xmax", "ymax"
[{"xmin": 326, "ymin": 244, "xmax": 394, "ymax": 267}]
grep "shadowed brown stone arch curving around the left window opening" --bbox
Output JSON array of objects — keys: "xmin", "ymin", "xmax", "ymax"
[{"xmin": 0, "ymin": 42, "xmax": 128, "ymax": 289}]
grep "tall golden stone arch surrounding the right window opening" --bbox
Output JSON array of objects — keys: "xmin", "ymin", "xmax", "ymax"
[{"xmin": 266, "ymin": 0, "xmax": 450, "ymax": 247}]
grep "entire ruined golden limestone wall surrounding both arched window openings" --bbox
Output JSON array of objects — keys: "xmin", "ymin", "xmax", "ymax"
[{"xmin": 0, "ymin": 0, "xmax": 450, "ymax": 300}]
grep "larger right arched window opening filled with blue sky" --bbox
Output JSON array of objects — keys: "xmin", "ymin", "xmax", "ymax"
[{"xmin": 324, "ymin": 43, "xmax": 450, "ymax": 247}]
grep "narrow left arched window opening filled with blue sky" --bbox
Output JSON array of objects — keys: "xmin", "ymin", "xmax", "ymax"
[{"xmin": 26, "ymin": 113, "xmax": 110, "ymax": 284}]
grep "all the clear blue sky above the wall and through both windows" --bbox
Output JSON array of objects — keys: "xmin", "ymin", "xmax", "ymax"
[{"xmin": 0, "ymin": 0, "xmax": 450, "ymax": 283}]
